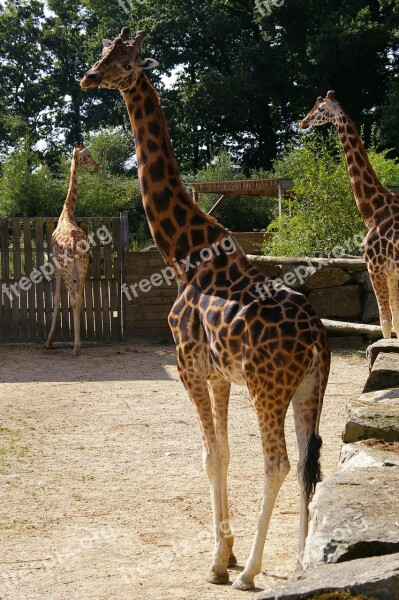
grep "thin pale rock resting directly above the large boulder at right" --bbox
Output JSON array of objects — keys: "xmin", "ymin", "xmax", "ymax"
[{"xmin": 339, "ymin": 440, "xmax": 399, "ymax": 471}]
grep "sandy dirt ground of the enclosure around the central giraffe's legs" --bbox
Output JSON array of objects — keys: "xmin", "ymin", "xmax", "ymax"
[{"xmin": 0, "ymin": 342, "xmax": 367, "ymax": 600}]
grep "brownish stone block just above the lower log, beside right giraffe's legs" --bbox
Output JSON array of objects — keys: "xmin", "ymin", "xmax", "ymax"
[{"xmin": 308, "ymin": 285, "xmax": 362, "ymax": 319}]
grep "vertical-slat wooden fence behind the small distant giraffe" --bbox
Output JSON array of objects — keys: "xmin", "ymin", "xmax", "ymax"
[{"xmin": 0, "ymin": 216, "xmax": 126, "ymax": 343}]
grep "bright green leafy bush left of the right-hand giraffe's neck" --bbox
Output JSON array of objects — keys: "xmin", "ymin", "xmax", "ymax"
[{"xmin": 265, "ymin": 130, "xmax": 365, "ymax": 256}]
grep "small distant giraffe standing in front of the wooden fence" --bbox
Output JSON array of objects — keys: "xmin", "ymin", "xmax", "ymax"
[{"xmin": 46, "ymin": 143, "xmax": 99, "ymax": 356}]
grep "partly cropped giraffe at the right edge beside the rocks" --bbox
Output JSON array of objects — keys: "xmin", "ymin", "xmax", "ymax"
[{"xmin": 299, "ymin": 91, "xmax": 399, "ymax": 338}]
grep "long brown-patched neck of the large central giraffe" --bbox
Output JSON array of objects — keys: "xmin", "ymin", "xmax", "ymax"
[{"xmin": 122, "ymin": 74, "xmax": 229, "ymax": 280}]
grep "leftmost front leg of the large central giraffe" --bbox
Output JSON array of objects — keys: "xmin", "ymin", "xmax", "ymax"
[{"xmin": 178, "ymin": 359, "xmax": 231, "ymax": 584}]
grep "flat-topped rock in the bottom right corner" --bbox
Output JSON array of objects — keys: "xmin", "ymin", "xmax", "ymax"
[{"xmin": 256, "ymin": 554, "xmax": 399, "ymax": 600}]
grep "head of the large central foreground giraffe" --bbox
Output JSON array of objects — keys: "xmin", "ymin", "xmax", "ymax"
[{"xmin": 80, "ymin": 27, "xmax": 158, "ymax": 91}]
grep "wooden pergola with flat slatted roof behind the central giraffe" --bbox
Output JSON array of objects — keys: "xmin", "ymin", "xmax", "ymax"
[{"xmin": 190, "ymin": 179, "xmax": 294, "ymax": 216}]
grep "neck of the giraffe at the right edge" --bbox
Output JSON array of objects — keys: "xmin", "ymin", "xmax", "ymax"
[{"xmin": 336, "ymin": 111, "xmax": 392, "ymax": 228}]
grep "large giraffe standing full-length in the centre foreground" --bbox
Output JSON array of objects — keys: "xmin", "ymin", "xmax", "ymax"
[{"xmin": 81, "ymin": 28, "xmax": 330, "ymax": 590}]
